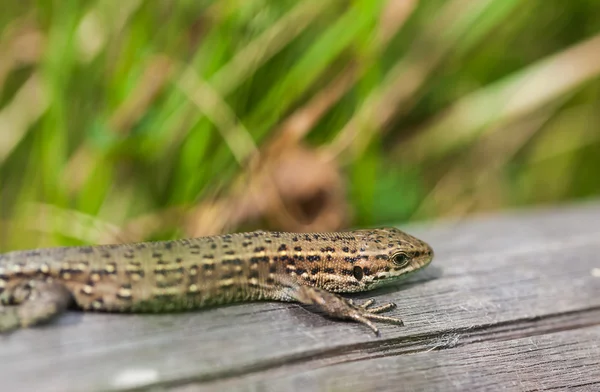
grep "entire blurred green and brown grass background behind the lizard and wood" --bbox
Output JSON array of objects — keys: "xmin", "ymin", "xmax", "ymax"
[{"xmin": 0, "ymin": 0, "xmax": 600, "ymax": 250}]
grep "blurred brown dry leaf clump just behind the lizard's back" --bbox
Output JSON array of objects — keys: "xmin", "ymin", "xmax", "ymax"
[{"xmin": 185, "ymin": 144, "xmax": 348, "ymax": 236}]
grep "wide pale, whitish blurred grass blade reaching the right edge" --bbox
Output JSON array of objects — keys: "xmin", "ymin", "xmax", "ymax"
[{"xmin": 396, "ymin": 35, "xmax": 600, "ymax": 161}]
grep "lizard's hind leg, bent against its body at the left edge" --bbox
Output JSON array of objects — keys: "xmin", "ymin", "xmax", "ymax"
[{"xmin": 0, "ymin": 281, "xmax": 73, "ymax": 333}]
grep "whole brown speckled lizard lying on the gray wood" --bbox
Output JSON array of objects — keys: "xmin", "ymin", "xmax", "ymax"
[{"xmin": 0, "ymin": 228, "xmax": 433, "ymax": 335}]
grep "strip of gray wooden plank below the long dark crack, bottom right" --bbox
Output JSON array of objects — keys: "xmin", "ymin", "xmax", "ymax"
[{"xmin": 190, "ymin": 326, "xmax": 600, "ymax": 392}]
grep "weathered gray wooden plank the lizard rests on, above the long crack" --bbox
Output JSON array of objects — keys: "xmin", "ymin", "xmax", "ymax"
[{"xmin": 0, "ymin": 203, "xmax": 600, "ymax": 391}]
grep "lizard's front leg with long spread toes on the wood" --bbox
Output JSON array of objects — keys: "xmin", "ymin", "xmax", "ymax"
[{"xmin": 289, "ymin": 285, "xmax": 403, "ymax": 335}]
